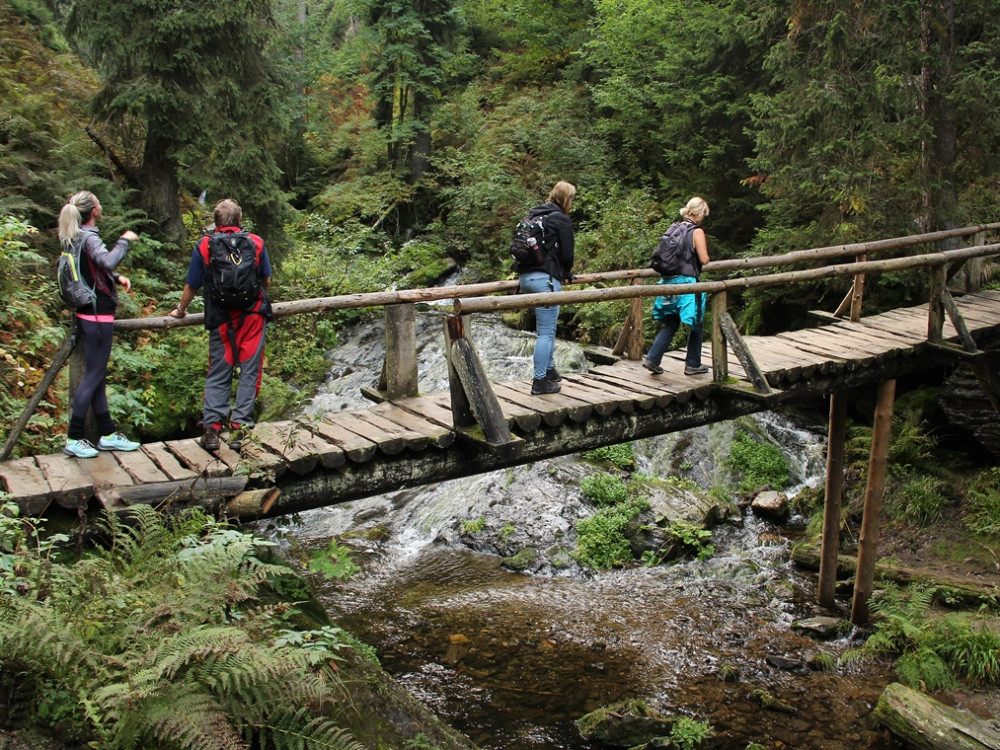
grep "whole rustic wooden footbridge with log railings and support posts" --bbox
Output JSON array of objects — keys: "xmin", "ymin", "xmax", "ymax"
[{"xmin": 0, "ymin": 224, "xmax": 1000, "ymax": 622}]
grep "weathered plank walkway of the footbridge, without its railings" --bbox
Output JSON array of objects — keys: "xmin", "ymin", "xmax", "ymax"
[{"xmin": 0, "ymin": 292, "xmax": 1000, "ymax": 515}]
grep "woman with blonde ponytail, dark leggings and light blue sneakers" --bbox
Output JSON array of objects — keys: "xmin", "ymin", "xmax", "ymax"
[{"xmin": 59, "ymin": 190, "xmax": 139, "ymax": 458}]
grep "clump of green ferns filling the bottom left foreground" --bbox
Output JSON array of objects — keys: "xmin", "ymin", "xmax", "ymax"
[{"xmin": 0, "ymin": 505, "xmax": 361, "ymax": 750}]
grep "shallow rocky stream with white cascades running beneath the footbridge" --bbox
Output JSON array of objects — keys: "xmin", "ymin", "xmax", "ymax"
[{"xmin": 258, "ymin": 309, "xmax": 885, "ymax": 750}]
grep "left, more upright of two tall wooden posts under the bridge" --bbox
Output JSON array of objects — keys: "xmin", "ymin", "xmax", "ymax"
[{"xmin": 818, "ymin": 393, "xmax": 847, "ymax": 607}]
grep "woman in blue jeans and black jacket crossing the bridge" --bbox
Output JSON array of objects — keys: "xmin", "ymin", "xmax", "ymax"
[{"xmin": 517, "ymin": 181, "xmax": 576, "ymax": 395}]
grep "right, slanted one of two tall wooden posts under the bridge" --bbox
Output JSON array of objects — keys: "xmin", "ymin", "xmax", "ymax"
[{"xmin": 851, "ymin": 382, "xmax": 896, "ymax": 625}]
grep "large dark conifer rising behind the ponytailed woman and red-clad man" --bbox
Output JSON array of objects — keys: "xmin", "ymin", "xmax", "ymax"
[{"xmin": 67, "ymin": 0, "xmax": 288, "ymax": 241}]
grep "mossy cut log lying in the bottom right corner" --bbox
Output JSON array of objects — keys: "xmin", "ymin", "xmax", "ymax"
[{"xmin": 874, "ymin": 682, "xmax": 1000, "ymax": 750}]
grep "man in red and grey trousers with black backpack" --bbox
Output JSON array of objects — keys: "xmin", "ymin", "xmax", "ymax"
[{"xmin": 170, "ymin": 198, "xmax": 271, "ymax": 451}]
